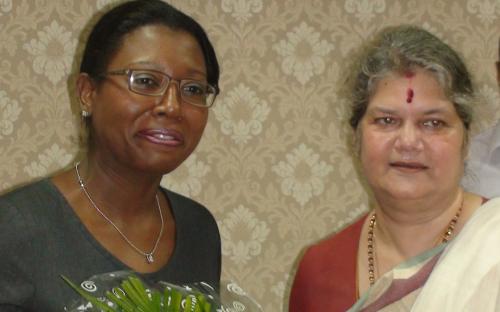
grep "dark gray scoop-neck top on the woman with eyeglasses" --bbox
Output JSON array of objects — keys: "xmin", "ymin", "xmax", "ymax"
[{"xmin": 0, "ymin": 179, "xmax": 221, "ymax": 312}]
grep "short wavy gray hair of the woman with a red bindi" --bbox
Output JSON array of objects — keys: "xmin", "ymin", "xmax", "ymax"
[{"xmin": 349, "ymin": 25, "xmax": 475, "ymax": 134}]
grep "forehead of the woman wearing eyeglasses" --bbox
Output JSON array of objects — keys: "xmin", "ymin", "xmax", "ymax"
[{"xmin": 108, "ymin": 24, "xmax": 206, "ymax": 73}]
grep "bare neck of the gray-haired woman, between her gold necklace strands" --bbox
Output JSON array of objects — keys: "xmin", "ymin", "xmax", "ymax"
[{"xmin": 375, "ymin": 189, "xmax": 463, "ymax": 259}]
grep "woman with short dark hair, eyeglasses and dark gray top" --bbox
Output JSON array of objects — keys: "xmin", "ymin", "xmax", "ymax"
[{"xmin": 0, "ymin": 0, "xmax": 221, "ymax": 311}]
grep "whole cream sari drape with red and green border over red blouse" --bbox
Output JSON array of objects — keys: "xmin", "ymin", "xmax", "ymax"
[{"xmin": 349, "ymin": 198, "xmax": 500, "ymax": 312}]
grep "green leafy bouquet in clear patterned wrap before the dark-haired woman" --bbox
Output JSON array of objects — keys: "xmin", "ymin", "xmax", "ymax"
[{"xmin": 62, "ymin": 271, "xmax": 262, "ymax": 312}]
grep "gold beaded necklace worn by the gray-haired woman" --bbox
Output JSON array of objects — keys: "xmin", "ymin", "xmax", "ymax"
[{"xmin": 367, "ymin": 194, "xmax": 464, "ymax": 286}]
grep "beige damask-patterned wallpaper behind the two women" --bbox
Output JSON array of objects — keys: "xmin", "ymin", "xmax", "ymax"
[{"xmin": 0, "ymin": 0, "xmax": 500, "ymax": 311}]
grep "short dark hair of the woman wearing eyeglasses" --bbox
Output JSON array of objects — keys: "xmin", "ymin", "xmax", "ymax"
[{"xmin": 80, "ymin": 0, "xmax": 220, "ymax": 90}]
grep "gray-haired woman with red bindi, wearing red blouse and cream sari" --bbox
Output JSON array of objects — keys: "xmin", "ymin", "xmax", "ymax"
[{"xmin": 290, "ymin": 26, "xmax": 500, "ymax": 312}]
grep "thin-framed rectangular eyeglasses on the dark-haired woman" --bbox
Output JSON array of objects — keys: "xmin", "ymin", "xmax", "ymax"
[{"xmin": 101, "ymin": 68, "xmax": 219, "ymax": 107}]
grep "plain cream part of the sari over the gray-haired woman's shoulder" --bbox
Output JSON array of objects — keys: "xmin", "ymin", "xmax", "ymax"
[{"xmin": 416, "ymin": 198, "xmax": 500, "ymax": 311}]
